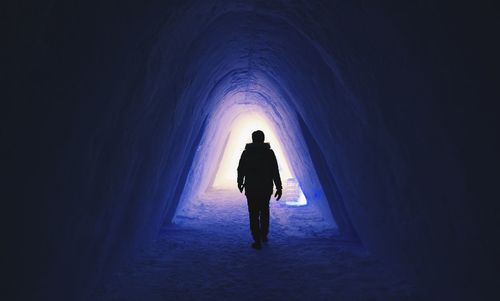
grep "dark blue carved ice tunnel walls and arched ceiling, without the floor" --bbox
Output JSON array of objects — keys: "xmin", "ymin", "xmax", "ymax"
[{"xmin": 1, "ymin": 0, "xmax": 500, "ymax": 300}]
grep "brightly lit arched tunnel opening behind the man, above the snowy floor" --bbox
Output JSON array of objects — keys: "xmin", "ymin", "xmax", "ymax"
[{"xmin": 173, "ymin": 79, "xmax": 345, "ymax": 228}]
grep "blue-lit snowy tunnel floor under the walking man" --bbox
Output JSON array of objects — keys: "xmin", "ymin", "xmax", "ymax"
[{"xmin": 91, "ymin": 191, "xmax": 419, "ymax": 301}]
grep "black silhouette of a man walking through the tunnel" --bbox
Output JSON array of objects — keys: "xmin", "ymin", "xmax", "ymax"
[{"xmin": 238, "ymin": 131, "xmax": 283, "ymax": 249}]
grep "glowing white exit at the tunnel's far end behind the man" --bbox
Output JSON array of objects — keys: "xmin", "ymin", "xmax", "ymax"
[{"xmin": 212, "ymin": 110, "xmax": 307, "ymax": 206}]
